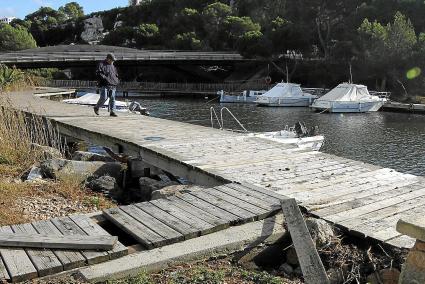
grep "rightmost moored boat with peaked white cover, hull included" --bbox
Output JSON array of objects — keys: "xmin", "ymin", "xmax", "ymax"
[{"xmin": 311, "ymin": 83, "xmax": 387, "ymax": 113}]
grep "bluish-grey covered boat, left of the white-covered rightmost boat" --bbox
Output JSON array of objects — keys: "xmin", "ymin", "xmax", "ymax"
[{"xmin": 255, "ymin": 83, "xmax": 317, "ymax": 107}]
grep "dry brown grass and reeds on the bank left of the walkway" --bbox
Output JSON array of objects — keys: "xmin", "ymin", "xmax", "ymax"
[{"xmin": 0, "ymin": 78, "xmax": 114, "ymax": 225}]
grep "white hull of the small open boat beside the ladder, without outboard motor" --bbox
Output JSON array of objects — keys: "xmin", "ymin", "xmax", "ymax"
[{"xmin": 249, "ymin": 124, "xmax": 325, "ymax": 151}]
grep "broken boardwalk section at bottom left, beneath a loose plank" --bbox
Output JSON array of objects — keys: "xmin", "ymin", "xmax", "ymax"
[{"xmin": 0, "ymin": 215, "xmax": 128, "ymax": 282}]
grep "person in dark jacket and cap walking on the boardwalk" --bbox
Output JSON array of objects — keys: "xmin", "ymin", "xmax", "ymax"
[{"xmin": 94, "ymin": 53, "xmax": 119, "ymax": 116}]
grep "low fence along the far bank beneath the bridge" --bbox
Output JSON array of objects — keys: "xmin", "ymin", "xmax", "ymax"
[{"xmin": 42, "ymin": 80, "xmax": 269, "ymax": 93}]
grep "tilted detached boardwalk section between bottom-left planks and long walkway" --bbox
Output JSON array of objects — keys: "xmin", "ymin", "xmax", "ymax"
[{"xmin": 103, "ymin": 184, "xmax": 286, "ymax": 248}]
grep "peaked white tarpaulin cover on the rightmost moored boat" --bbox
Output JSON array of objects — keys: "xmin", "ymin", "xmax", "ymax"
[{"xmin": 317, "ymin": 83, "xmax": 380, "ymax": 102}]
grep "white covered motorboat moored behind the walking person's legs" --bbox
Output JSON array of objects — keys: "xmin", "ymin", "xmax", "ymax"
[{"xmin": 63, "ymin": 93, "xmax": 149, "ymax": 115}]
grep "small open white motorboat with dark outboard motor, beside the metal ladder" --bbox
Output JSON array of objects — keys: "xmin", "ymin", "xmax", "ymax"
[{"xmin": 249, "ymin": 122, "xmax": 325, "ymax": 151}]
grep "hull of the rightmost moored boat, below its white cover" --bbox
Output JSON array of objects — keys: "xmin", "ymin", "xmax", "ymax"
[{"xmin": 311, "ymin": 101, "xmax": 384, "ymax": 113}]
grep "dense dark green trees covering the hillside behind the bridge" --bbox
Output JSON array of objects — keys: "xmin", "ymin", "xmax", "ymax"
[{"xmin": 0, "ymin": 0, "xmax": 425, "ymax": 93}]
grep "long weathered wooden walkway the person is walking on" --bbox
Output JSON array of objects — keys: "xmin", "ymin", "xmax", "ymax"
[{"xmin": 4, "ymin": 93, "xmax": 425, "ymax": 251}]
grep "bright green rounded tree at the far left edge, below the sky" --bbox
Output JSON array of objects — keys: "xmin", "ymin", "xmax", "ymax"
[{"xmin": 0, "ymin": 24, "xmax": 37, "ymax": 51}]
